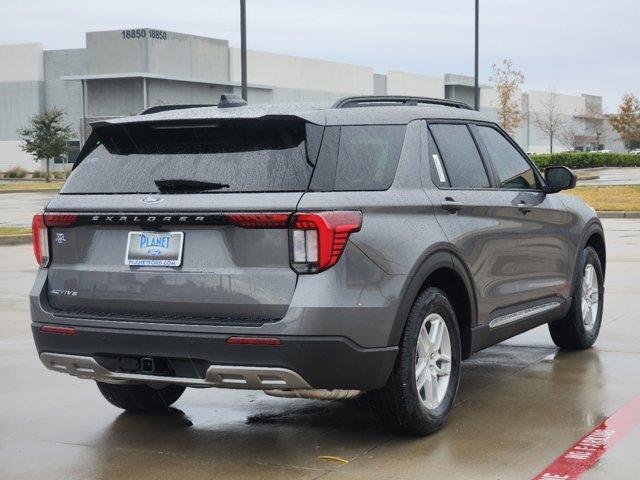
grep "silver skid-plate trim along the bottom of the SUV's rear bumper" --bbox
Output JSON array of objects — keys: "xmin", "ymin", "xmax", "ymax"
[{"xmin": 40, "ymin": 352, "xmax": 313, "ymax": 390}]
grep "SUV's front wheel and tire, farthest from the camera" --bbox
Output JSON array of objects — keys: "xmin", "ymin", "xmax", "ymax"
[{"xmin": 549, "ymin": 247, "xmax": 604, "ymax": 350}]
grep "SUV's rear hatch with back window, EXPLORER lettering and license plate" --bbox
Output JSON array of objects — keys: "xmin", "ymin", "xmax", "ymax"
[{"xmin": 46, "ymin": 118, "xmax": 323, "ymax": 325}]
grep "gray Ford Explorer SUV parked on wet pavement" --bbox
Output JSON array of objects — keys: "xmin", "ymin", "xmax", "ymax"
[{"xmin": 30, "ymin": 95, "xmax": 606, "ymax": 434}]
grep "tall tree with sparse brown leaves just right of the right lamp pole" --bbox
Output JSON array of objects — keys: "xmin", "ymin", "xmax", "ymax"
[{"xmin": 489, "ymin": 59, "xmax": 524, "ymax": 135}]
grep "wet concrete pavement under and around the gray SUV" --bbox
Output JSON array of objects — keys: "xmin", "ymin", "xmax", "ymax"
[{"xmin": 0, "ymin": 220, "xmax": 640, "ymax": 480}]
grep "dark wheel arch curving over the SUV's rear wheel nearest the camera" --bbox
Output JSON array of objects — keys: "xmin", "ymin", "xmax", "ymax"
[{"xmin": 390, "ymin": 248, "xmax": 477, "ymax": 359}]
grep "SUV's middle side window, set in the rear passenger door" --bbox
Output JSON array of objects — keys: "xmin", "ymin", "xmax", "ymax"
[{"xmin": 429, "ymin": 124, "xmax": 490, "ymax": 188}]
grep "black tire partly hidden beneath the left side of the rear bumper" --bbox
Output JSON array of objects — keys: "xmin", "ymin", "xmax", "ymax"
[{"xmin": 96, "ymin": 382, "xmax": 185, "ymax": 413}]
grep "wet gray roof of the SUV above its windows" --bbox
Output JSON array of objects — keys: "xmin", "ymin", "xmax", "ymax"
[{"xmin": 99, "ymin": 102, "xmax": 489, "ymax": 125}]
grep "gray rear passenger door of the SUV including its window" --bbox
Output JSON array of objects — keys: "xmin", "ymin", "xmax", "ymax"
[{"xmin": 424, "ymin": 121, "xmax": 527, "ymax": 324}]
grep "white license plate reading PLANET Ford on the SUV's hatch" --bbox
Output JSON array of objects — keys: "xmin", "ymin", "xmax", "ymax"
[{"xmin": 124, "ymin": 232, "xmax": 184, "ymax": 267}]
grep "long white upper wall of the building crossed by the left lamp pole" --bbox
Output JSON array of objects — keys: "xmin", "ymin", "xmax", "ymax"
[{"xmin": 230, "ymin": 47, "xmax": 373, "ymax": 95}]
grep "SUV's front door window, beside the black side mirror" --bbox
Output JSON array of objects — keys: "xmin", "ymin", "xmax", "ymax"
[{"xmin": 478, "ymin": 126, "xmax": 538, "ymax": 189}]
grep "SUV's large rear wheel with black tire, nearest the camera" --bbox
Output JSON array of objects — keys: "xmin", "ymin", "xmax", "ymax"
[{"xmin": 369, "ymin": 288, "xmax": 461, "ymax": 435}]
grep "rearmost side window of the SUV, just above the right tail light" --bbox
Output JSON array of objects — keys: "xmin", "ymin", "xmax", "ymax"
[{"xmin": 334, "ymin": 125, "xmax": 407, "ymax": 191}]
